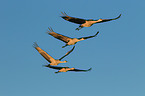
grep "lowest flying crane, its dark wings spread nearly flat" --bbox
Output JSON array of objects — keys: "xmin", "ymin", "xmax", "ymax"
[{"xmin": 44, "ymin": 65, "xmax": 92, "ymax": 73}]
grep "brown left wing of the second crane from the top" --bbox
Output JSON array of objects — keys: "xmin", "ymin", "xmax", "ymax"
[{"xmin": 47, "ymin": 28, "xmax": 72, "ymax": 43}]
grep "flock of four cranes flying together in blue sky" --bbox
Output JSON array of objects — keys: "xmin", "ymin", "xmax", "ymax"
[{"xmin": 33, "ymin": 12, "xmax": 121, "ymax": 73}]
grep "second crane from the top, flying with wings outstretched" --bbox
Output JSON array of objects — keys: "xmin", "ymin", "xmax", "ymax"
[{"xmin": 47, "ymin": 27, "xmax": 99, "ymax": 48}]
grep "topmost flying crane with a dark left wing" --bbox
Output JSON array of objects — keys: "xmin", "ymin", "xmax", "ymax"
[{"xmin": 61, "ymin": 12, "xmax": 121, "ymax": 30}]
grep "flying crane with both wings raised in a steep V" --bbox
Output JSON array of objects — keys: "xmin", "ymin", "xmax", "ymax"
[{"xmin": 33, "ymin": 42, "xmax": 75, "ymax": 65}]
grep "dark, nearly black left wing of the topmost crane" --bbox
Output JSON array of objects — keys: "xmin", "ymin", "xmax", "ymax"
[{"xmin": 61, "ymin": 12, "xmax": 86, "ymax": 24}]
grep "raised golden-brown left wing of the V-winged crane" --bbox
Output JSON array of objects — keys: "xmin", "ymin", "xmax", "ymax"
[{"xmin": 33, "ymin": 42, "xmax": 55, "ymax": 63}]
